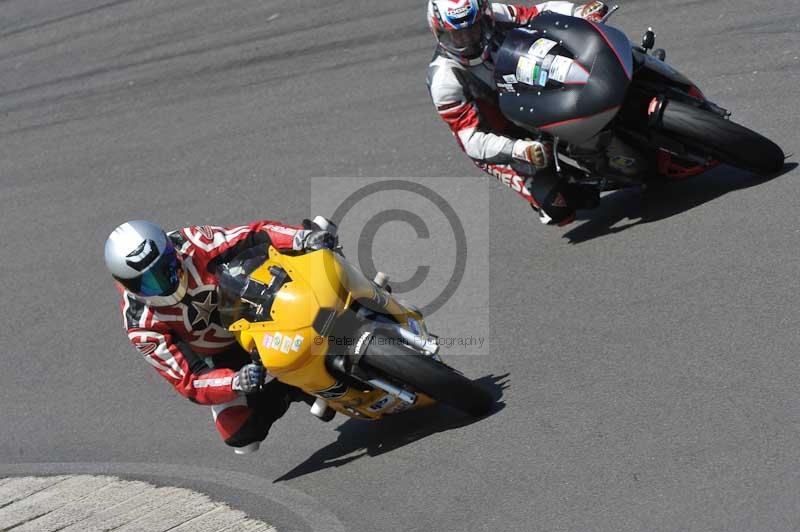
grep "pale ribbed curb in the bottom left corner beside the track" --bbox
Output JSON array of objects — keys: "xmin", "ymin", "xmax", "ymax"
[{"xmin": 0, "ymin": 475, "xmax": 276, "ymax": 532}]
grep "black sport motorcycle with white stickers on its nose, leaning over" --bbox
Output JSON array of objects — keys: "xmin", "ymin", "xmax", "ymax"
[{"xmin": 495, "ymin": 8, "xmax": 784, "ymax": 190}]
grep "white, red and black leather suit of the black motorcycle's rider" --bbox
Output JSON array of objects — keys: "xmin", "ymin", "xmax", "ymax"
[{"xmin": 428, "ymin": 1, "xmax": 575, "ymax": 207}]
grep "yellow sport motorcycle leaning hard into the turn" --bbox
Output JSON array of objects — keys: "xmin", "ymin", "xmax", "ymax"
[{"xmin": 219, "ymin": 246, "xmax": 494, "ymax": 421}]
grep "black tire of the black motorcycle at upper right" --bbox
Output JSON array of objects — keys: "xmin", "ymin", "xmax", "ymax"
[{"xmin": 661, "ymin": 100, "xmax": 784, "ymax": 174}]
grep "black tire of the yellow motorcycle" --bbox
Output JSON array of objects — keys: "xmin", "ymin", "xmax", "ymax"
[{"xmin": 359, "ymin": 337, "xmax": 494, "ymax": 417}]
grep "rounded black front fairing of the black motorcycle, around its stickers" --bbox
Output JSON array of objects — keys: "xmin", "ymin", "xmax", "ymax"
[{"xmin": 495, "ymin": 13, "xmax": 633, "ymax": 144}]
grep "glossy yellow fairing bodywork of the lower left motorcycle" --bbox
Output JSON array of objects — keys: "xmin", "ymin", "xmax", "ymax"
[{"xmin": 230, "ymin": 247, "xmax": 432, "ymax": 419}]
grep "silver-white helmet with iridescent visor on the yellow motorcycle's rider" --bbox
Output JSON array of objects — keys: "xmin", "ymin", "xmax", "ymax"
[{"xmin": 105, "ymin": 220, "xmax": 185, "ymax": 304}]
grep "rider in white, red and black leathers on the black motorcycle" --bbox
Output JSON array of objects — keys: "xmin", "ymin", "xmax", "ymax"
[{"xmin": 428, "ymin": 0, "xmax": 608, "ymax": 225}]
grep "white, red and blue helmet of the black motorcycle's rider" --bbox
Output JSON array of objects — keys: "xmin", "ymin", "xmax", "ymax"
[{"xmin": 428, "ymin": 0, "xmax": 494, "ymax": 65}]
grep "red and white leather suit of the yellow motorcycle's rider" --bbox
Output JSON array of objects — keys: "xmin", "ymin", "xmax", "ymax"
[{"xmin": 120, "ymin": 220, "xmax": 306, "ymax": 441}]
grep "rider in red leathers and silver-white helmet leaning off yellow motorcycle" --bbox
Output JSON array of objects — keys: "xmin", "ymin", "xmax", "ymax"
[{"xmin": 105, "ymin": 217, "xmax": 336, "ymax": 454}]
